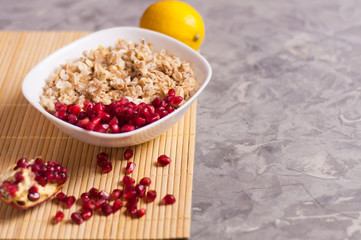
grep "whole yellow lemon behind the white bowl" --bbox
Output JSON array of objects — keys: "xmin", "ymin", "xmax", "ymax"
[{"xmin": 139, "ymin": 1, "xmax": 204, "ymax": 50}]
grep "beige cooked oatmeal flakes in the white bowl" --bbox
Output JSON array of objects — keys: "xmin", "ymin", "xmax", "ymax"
[{"xmin": 40, "ymin": 39, "xmax": 196, "ymax": 112}]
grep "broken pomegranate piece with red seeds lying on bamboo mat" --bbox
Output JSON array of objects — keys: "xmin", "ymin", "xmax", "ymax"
[{"xmin": 0, "ymin": 158, "xmax": 67, "ymax": 210}]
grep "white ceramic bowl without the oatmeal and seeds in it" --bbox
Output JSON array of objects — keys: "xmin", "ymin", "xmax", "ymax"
[{"xmin": 22, "ymin": 27, "xmax": 212, "ymax": 147}]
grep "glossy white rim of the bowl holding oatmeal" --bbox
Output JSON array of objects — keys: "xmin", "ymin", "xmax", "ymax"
[{"xmin": 22, "ymin": 26, "xmax": 212, "ymax": 139}]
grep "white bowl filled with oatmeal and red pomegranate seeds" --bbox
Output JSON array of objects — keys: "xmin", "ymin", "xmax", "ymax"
[{"xmin": 22, "ymin": 27, "xmax": 212, "ymax": 147}]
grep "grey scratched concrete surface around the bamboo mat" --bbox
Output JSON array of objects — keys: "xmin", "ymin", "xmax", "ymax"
[{"xmin": 0, "ymin": 0, "xmax": 361, "ymax": 240}]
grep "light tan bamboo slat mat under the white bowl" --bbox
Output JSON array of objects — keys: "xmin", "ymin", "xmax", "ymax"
[{"xmin": 0, "ymin": 31, "xmax": 196, "ymax": 239}]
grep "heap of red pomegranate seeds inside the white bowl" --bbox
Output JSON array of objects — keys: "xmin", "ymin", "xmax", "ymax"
[{"xmin": 54, "ymin": 89, "xmax": 183, "ymax": 133}]
